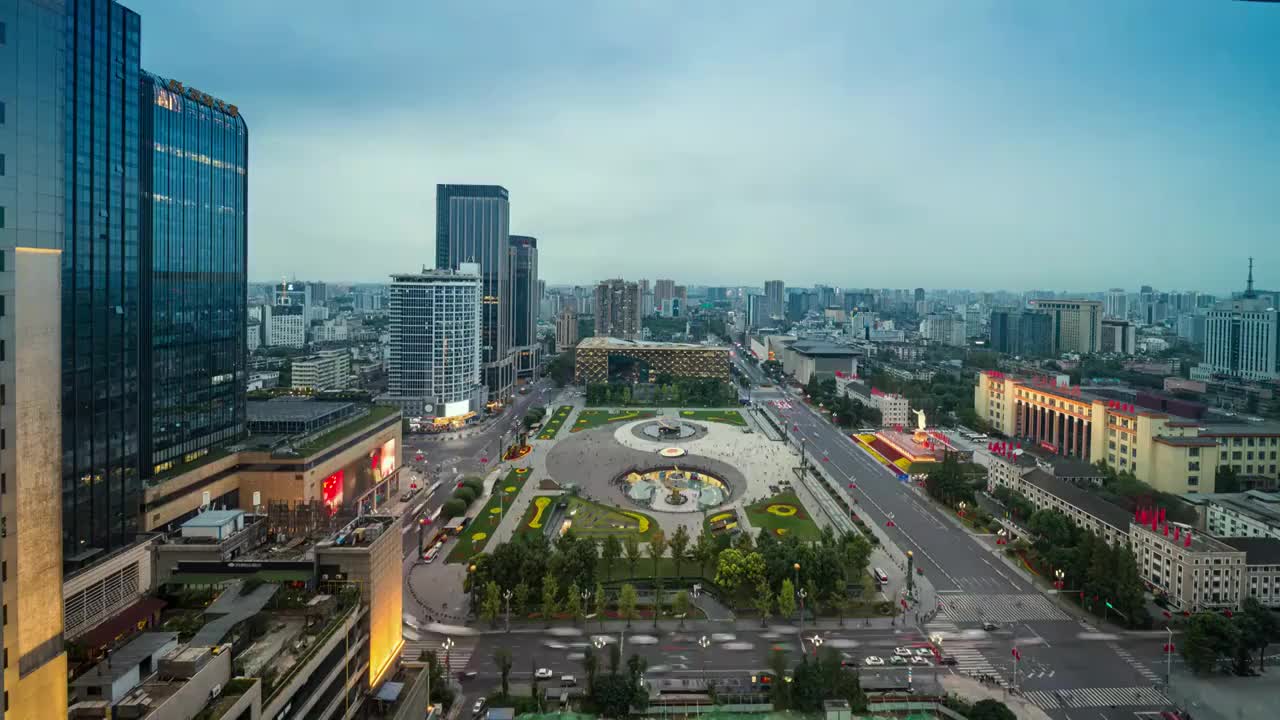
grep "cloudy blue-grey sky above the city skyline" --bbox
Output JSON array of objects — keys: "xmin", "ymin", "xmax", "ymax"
[{"xmin": 123, "ymin": 0, "xmax": 1280, "ymax": 291}]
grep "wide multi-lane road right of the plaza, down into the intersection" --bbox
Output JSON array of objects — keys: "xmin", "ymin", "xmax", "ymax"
[{"xmin": 739, "ymin": 351, "xmax": 1176, "ymax": 719}]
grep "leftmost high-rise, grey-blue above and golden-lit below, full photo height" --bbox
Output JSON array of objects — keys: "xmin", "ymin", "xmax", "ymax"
[{"xmin": 0, "ymin": 0, "xmax": 72, "ymax": 719}]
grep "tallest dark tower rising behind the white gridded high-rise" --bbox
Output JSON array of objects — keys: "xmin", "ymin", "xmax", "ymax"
[{"xmin": 435, "ymin": 184, "xmax": 516, "ymax": 402}]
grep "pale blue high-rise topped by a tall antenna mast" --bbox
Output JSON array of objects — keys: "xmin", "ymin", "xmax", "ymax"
[{"xmin": 1203, "ymin": 258, "xmax": 1280, "ymax": 380}]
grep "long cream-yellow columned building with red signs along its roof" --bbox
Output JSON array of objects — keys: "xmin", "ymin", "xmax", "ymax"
[{"xmin": 974, "ymin": 372, "xmax": 1244, "ymax": 495}]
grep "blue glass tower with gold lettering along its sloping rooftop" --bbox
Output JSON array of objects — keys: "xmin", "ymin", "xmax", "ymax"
[{"xmin": 138, "ymin": 72, "xmax": 248, "ymax": 477}]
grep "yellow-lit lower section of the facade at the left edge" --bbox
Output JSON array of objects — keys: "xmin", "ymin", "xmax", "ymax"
[{"xmin": 0, "ymin": 247, "xmax": 67, "ymax": 720}]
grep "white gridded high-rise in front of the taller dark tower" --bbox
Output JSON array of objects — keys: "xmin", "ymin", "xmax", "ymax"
[{"xmin": 379, "ymin": 263, "xmax": 485, "ymax": 425}]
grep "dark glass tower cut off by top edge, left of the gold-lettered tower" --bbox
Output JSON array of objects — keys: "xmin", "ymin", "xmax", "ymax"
[{"xmin": 61, "ymin": 0, "xmax": 142, "ymax": 564}]
